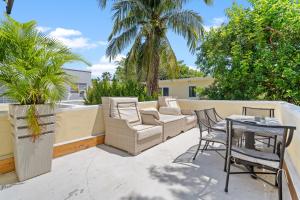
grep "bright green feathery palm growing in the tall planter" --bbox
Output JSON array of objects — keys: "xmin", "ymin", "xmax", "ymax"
[{"xmin": 0, "ymin": 16, "xmax": 88, "ymax": 135}]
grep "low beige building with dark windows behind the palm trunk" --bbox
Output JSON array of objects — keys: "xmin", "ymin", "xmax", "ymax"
[{"xmin": 159, "ymin": 77, "xmax": 214, "ymax": 99}]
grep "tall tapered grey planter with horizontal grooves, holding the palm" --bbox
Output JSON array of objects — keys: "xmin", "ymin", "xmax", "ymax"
[{"xmin": 9, "ymin": 104, "xmax": 55, "ymax": 181}]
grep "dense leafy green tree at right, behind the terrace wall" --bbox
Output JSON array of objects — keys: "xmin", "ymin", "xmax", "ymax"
[{"xmin": 196, "ymin": 0, "xmax": 300, "ymax": 104}]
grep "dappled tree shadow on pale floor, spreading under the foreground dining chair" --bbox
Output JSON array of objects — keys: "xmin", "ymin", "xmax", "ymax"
[{"xmin": 149, "ymin": 145, "xmax": 272, "ymax": 200}]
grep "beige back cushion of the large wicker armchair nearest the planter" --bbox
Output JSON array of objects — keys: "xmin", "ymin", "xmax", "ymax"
[{"xmin": 110, "ymin": 97, "xmax": 142, "ymax": 125}]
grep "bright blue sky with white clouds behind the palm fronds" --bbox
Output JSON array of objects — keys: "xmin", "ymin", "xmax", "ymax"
[{"xmin": 0, "ymin": 0, "xmax": 249, "ymax": 77}]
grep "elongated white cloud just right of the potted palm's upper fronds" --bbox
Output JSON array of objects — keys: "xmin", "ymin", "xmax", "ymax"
[{"xmin": 49, "ymin": 28, "xmax": 100, "ymax": 49}]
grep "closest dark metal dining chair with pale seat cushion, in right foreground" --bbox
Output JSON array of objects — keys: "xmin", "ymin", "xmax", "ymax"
[{"xmin": 225, "ymin": 119, "xmax": 296, "ymax": 200}]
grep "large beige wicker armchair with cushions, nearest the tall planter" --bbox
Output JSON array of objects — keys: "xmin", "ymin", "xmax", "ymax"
[{"xmin": 102, "ymin": 97, "xmax": 162, "ymax": 155}]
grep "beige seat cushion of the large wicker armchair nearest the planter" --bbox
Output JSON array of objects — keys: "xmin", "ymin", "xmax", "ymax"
[{"xmin": 133, "ymin": 124, "xmax": 162, "ymax": 140}]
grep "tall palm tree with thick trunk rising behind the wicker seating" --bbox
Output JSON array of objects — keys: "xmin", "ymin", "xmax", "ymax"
[{"xmin": 104, "ymin": 0, "xmax": 212, "ymax": 95}]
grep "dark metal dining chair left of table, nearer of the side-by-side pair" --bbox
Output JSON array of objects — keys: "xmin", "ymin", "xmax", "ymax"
[{"xmin": 193, "ymin": 108, "xmax": 226, "ymax": 160}]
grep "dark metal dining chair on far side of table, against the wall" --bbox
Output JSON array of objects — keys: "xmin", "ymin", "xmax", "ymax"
[{"xmin": 242, "ymin": 106, "xmax": 277, "ymax": 152}]
